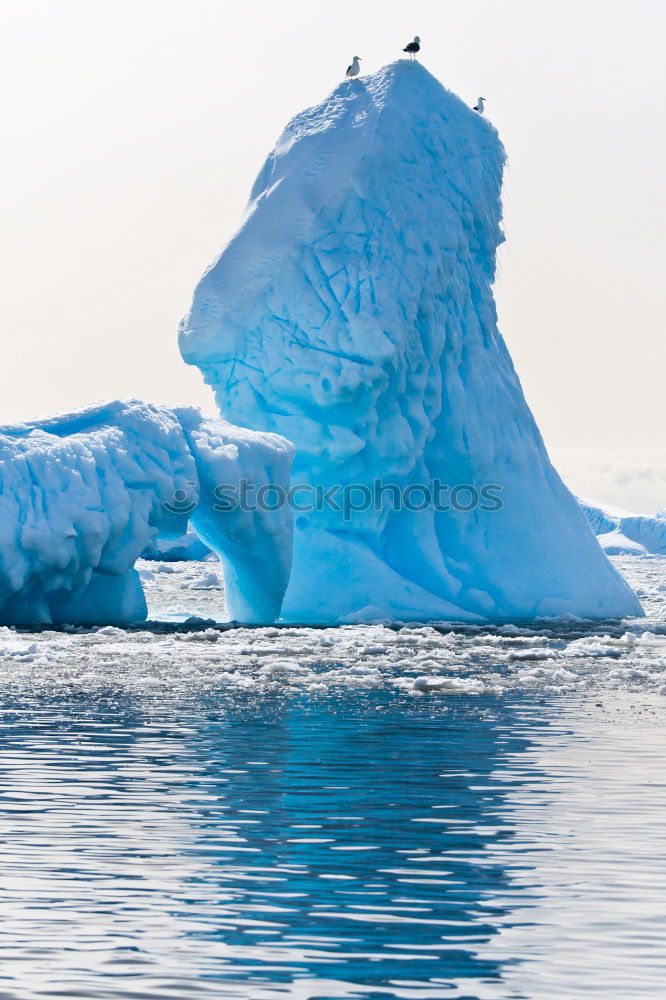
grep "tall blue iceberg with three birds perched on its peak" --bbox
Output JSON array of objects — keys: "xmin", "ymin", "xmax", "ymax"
[{"xmin": 180, "ymin": 61, "xmax": 641, "ymax": 622}]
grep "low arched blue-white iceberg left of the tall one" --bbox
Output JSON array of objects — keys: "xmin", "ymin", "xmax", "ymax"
[{"xmin": 0, "ymin": 401, "xmax": 293, "ymax": 624}]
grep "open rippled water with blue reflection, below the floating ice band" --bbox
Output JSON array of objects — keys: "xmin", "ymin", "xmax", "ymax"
[{"xmin": 0, "ymin": 660, "xmax": 666, "ymax": 1000}]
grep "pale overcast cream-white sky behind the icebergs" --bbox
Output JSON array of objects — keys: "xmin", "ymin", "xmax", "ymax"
[{"xmin": 0, "ymin": 0, "xmax": 666, "ymax": 462}]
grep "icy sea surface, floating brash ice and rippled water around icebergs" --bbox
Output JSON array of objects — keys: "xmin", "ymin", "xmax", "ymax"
[{"xmin": 0, "ymin": 556, "xmax": 666, "ymax": 1000}]
